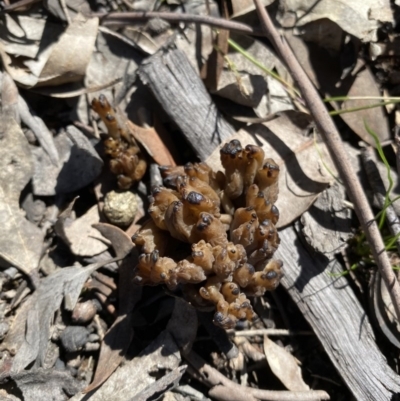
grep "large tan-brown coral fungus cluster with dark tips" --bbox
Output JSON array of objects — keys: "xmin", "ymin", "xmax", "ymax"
[{"xmin": 133, "ymin": 140, "xmax": 282, "ymax": 328}]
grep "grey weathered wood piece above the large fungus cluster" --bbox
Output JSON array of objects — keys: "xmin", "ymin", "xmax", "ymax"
[{"xmin": 139, "ymin": 48, "xmax": 234, "ymax": 160}]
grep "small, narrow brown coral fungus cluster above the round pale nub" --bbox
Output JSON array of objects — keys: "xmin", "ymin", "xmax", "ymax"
[{"xmin": 92, "ymin": 95, "xmax": 147, "ymax": 189}]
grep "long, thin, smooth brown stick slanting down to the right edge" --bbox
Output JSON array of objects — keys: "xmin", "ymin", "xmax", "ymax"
[{"xmin": 254, "ymin": 0, "xmax": 400, "ymax": 321}]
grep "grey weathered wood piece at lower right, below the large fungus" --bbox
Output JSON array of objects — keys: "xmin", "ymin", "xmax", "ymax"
[{"xmin": 275, "ymin": 227, "xmax": 400, "ymax": 401}]
